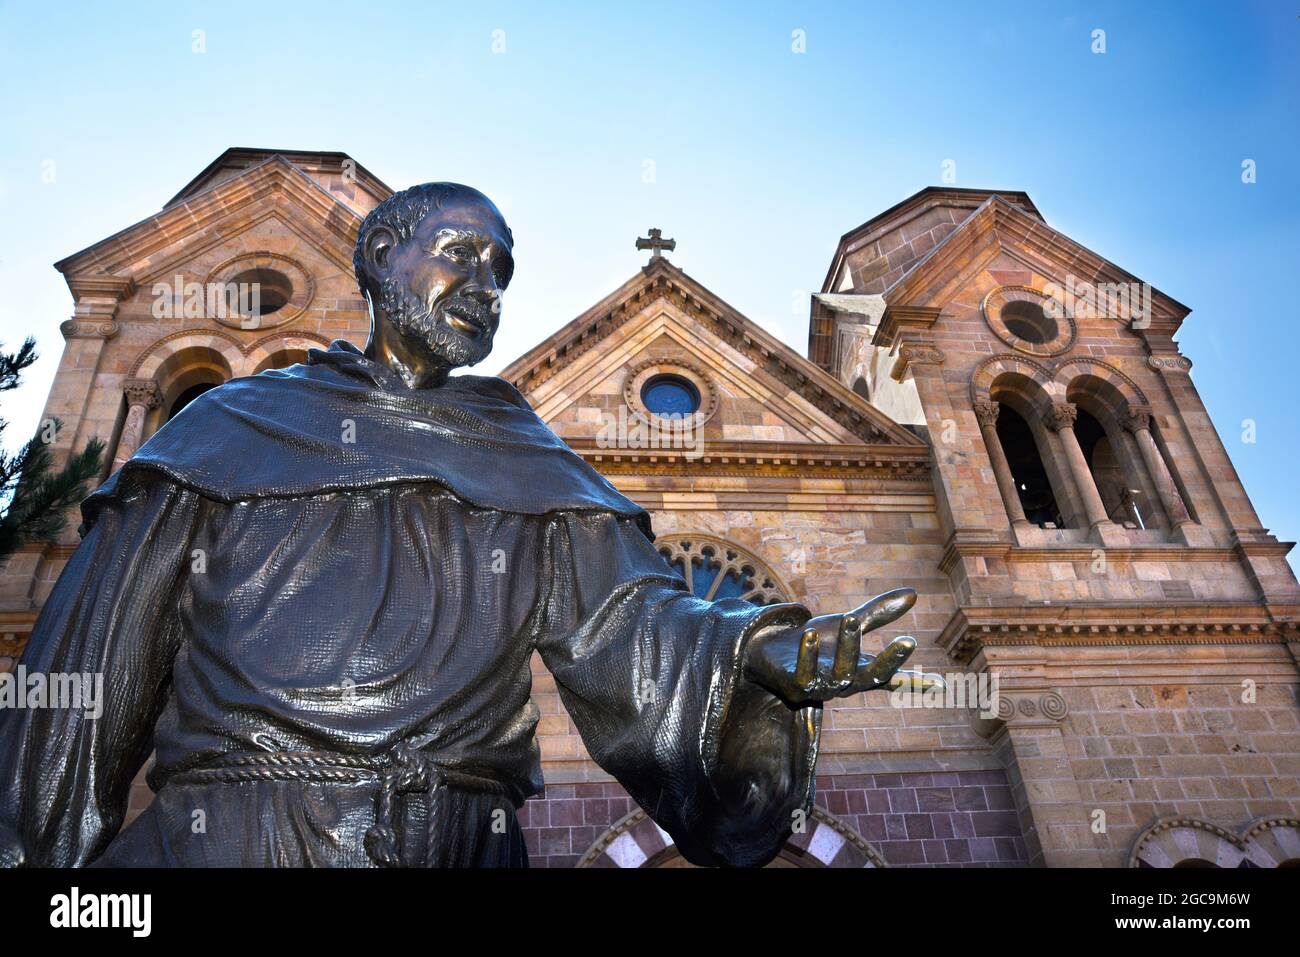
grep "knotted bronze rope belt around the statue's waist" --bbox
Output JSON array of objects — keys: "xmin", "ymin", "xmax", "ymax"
[{"xmin": 168, "ymin": 741, "xmax": 511, "ymax": 867}]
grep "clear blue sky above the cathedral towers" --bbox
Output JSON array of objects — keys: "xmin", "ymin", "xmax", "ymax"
[{"xmin": 0, "ymin": 1, "xmax": 1300, "ymax": 560}]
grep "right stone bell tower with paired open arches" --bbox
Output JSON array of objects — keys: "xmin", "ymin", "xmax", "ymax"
[{"xmin": 809, "ymin": 189, "xmax": 1300, "ymax": 866}]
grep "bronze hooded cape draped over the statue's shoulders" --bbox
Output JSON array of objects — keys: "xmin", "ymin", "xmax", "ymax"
[{"xmin": 82, "ymin": 339, "xmax": 654, "ymax": 540}]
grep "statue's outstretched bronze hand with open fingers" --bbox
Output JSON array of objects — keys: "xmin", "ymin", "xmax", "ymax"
[{"xmin": 745, "ymin": 588, "xmax": 944, "ymax": 705}]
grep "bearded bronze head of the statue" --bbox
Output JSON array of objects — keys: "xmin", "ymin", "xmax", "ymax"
[{"xmin": 352, "ymin": 183, "xmax": 515, "ymax": 387}]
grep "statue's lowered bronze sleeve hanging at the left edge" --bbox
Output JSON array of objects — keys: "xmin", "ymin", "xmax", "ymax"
[{"xmin": 0, "ymin": 476, "xmax": 203, "ymax": 867}]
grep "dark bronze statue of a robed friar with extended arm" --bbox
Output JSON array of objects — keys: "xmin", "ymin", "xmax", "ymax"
[{"xmin": 0, "ymin": 183, "xmax": 933, "ymax": 866}]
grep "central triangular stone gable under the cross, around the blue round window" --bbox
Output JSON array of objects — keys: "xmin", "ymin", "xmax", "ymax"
[{"xmin": 501, "ymin": 259, "xmax": 927, "ymax": 450}]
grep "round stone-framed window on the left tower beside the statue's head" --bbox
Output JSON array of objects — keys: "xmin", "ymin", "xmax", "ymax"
[{"xmin": 205, "ymin": 252, "xmax": 316, "ymax": 332}]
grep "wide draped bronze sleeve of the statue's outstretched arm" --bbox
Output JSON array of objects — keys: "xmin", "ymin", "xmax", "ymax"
[{"xmin": 538, "ymin": 512, "xmax": 822, "ymax": 866}]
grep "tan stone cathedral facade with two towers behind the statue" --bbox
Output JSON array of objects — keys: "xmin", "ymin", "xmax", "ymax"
[{"xmin": 0, "ymin": 150, "xmax": 1300, "ymax": 867}]
